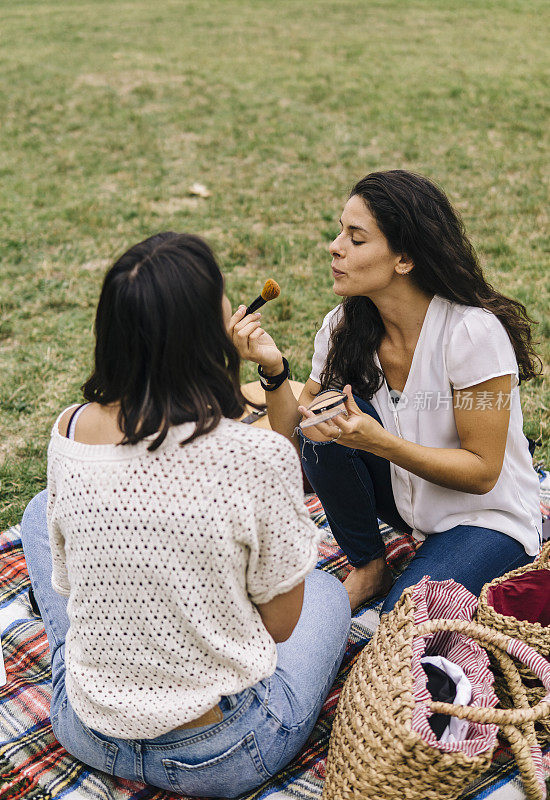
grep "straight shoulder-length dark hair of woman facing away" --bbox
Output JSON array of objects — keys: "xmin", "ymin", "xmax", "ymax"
[{"xmin": 82, "ymin": 232, "xmax": 246, "ymax": 450}]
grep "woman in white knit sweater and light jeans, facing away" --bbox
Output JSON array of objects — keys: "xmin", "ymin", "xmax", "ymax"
[{"xmin": 21, "ymin": 233, "xmax": 350, "ymax": 797}]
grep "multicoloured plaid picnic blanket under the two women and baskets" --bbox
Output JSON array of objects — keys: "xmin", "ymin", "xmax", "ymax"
[{"xmin": 0, "ymin": 488, "xmax": 550, "ymax": 800}]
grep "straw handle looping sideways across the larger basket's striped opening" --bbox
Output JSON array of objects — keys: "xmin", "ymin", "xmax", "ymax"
[{"xmin": 416, "ymin": 619, "xmax": 550, "ymax": 725}]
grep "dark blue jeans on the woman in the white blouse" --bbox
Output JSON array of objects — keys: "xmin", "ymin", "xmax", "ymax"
[{"xmin": 298, "ymin": 397, "xmax": 533, "ymax": 612}]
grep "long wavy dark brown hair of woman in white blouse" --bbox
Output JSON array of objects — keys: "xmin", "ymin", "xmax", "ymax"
[{"xmin": 321, "ymin": 170, "xmax": 542, "ymax": 400}]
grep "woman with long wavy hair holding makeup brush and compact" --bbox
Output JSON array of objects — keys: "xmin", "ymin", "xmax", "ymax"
[{"xmin": 233, "ymin": 170, "xmax": 542, "ymax": 611}]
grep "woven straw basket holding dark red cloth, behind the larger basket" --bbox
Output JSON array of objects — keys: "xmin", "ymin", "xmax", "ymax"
[{"xmin": 475, "ymin": 542, "xmax": 550, "ymax": 744}]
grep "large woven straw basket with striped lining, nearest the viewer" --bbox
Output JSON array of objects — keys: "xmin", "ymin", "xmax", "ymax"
[{"xmin": 323, "ymin": 587, "xmax": 550, "ymax": 800}]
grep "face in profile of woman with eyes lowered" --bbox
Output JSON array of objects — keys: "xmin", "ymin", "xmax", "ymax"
[{"xmin": 329, "ymin": 195, "xmax": 408, "ymax": 297}]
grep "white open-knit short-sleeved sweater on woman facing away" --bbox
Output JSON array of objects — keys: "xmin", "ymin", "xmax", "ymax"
[{"xmin": 48, "ymin": 419, "xmax": 319, "ymax": 739}]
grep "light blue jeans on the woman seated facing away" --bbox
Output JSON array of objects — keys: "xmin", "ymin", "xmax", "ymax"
[{"xmin": 21, "ymin": 492, "xmax": 351, "ymax": 797}]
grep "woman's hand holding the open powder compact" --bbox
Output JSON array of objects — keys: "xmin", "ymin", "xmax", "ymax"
[{"xmin": 298, "ymin": 384, "xmax": 386, "ymax": 452}]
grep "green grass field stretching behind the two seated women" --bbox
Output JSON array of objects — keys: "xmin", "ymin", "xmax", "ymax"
[{"xmin": 0, "ymin": 0, "xmax": 550, "ymax": 527}]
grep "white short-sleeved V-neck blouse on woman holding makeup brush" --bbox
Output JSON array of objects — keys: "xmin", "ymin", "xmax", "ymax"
[{"xmin": 310, "ymin": 295, "xmax": 542, "ymax": 556}]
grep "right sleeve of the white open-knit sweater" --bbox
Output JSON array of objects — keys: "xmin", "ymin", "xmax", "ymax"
[{"xmin": 242, "ymin": 437, "xmax": 321, "ymax": 604}]
